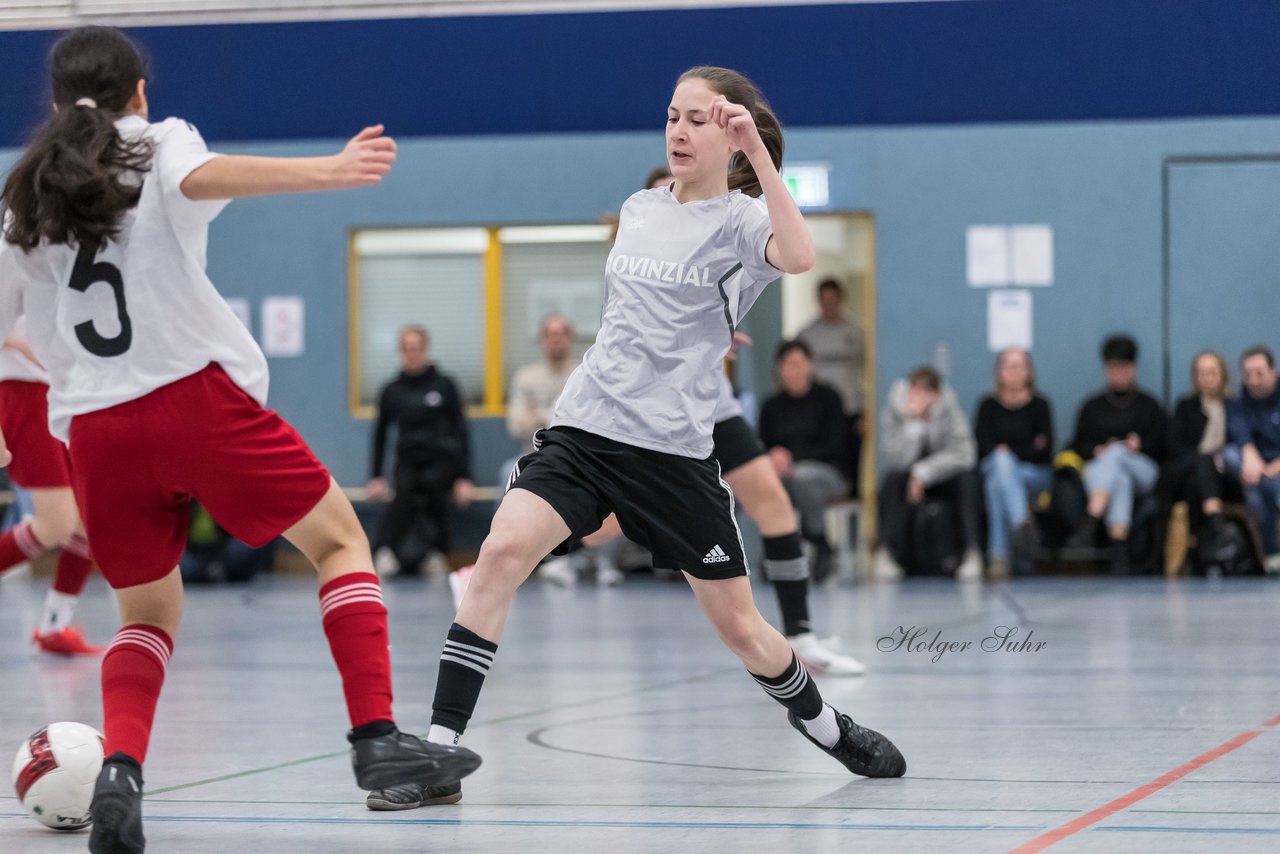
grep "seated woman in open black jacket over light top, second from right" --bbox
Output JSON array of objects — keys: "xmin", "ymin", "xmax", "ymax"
[{"xmin": 1162, "ymin": 350, "xmax": 1230, "ymax": 563}]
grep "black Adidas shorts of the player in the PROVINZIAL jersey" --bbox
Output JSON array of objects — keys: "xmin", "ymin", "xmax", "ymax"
[{"xmin": 511, "ymin": 426, "xmax": 749, "ymax": 579}]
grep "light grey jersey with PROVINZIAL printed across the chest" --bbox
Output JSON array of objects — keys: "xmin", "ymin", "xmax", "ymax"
[{"xmin": 552, "ymin": 187, "xmax": 781, "ymax": 460}]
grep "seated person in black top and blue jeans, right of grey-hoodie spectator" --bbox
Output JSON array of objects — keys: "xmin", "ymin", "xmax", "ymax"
[{"xmin": 974, "ymin": 347, "xmax": 1053, "ymax": 580}]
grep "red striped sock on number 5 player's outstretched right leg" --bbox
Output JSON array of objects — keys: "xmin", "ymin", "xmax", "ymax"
[{"xmin": 320, "ymin": 572, "xmax": 393, "ymax": 727}]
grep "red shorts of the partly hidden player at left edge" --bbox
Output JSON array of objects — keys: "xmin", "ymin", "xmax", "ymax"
[{"xmin": 0, "ymin": 379, "xmax": 72, "ymax": 489}]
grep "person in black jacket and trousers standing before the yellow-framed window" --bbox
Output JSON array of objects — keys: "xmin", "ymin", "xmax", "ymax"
[{"xmin": 366, "ymin": 325, "xmax": 474, "ymax": 574}]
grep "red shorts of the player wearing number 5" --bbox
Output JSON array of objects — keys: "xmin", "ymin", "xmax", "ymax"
[{"xmin": 70, "ymin": 365, "xmax": 330, "ymax": 588}]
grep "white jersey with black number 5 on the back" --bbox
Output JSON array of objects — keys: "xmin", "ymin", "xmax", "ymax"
[{"xmin": 0, "ymin": 117, "xmax": 268, "ymax": 442}]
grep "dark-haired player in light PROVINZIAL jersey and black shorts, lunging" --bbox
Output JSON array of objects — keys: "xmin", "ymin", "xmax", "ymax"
[{"xmin": 369, "ymin": 68, "xmax": 906, "ymax": 809}]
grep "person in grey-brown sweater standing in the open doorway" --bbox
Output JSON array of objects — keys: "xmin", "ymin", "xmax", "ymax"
[{"xmin": 796, "ymin": 279, "xmax": 867, "ymax": 479}]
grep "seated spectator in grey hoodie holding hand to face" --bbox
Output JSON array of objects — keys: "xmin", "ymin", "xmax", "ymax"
[{"xmin": 876, "ymin": 367, "xmax": 982, "ymax": 581}]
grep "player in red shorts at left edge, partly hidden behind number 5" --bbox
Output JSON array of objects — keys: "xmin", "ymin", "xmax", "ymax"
[{"xmin": 0, "ymin": 321, "xmax": 102, "ymax": 656}]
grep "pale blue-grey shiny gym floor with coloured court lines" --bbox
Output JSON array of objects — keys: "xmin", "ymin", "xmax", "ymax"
[{"xmin": 0, "ymin": 577, "xmax": 1280, "ymax": 854}]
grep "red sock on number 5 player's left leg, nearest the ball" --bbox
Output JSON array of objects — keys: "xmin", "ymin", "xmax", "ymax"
[{"xmin": 102, "ymin": 624, "xmax": 173, "ymax": 764}]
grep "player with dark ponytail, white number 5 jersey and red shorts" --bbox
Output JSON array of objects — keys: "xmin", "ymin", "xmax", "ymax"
[{"xmin": 0, "ymin": 27, "xmax": 480, "ymax": 854}]
